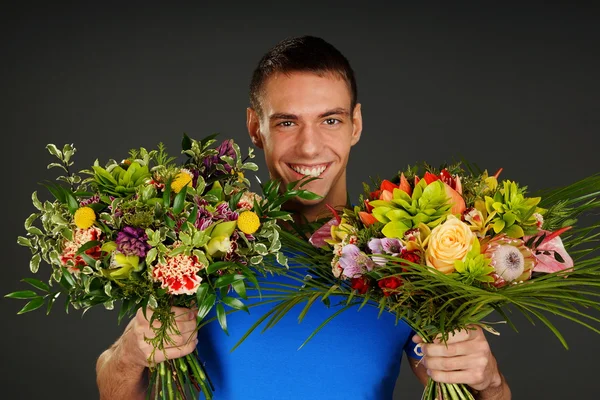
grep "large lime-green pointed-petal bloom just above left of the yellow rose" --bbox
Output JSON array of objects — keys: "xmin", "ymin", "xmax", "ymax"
[{"xmin": 369, "ymin": 179, "xmax": 452, "ymax": 239}]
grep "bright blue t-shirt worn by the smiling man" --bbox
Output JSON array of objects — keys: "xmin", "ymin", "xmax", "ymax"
[{"xmin": 198, "ymin": 264, "xmax": 420, "ymax": 400}]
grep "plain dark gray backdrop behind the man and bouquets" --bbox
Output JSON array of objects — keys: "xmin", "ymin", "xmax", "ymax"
[{"xmin": 0, "ymin": 1, "xmax": 600, "ymax": 400}]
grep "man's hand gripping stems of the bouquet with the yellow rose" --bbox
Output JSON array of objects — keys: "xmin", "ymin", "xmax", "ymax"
[{"xmin": 413, "ymin": 326, "xmax": 510, "ymax": 399}]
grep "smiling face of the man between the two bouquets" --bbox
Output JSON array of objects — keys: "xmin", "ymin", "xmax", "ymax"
[{"xmin": 248, "ymin": 72, "xmax": 362, "ymax": 206}]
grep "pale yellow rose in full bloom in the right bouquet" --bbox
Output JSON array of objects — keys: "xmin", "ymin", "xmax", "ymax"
[{"xmin": 425, "ymin": 215, "xmax": 473, "ymax": 274}]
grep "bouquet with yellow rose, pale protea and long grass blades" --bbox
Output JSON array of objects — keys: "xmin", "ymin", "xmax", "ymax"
[{"xmin": 252, "ymin": 163, "xmax": 600, "ymax": 400}]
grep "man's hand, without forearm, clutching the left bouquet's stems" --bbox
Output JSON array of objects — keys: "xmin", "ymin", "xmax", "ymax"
[{"xmin": 119, "ymin": 307, "xmax": 198, "ymax": 367}]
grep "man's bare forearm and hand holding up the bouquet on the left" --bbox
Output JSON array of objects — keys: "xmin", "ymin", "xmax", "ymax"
[{"xmin": 96, "ymin": 307, "xmax": 198, "ymax": 400}]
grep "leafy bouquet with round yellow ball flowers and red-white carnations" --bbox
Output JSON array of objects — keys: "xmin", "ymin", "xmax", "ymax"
[{"xmin": 6, "ymin": 135, "xmax": 315, "ymax": 399}]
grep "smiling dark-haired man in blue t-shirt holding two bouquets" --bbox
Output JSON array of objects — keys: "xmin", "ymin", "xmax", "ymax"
[{"xmin": 97, "ymin": 37, "xmax": 510, "ymax": 400}]
